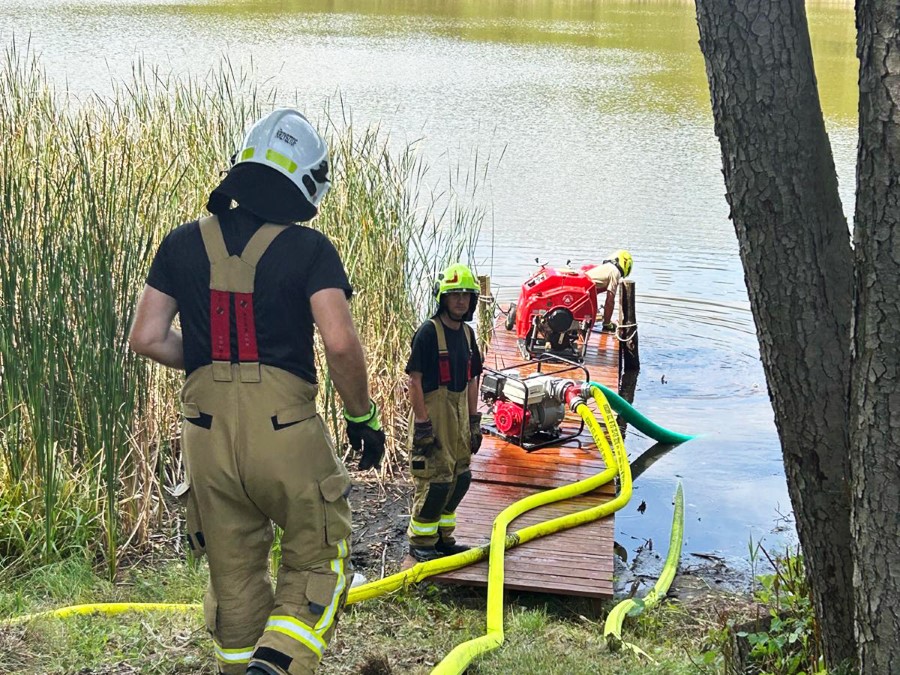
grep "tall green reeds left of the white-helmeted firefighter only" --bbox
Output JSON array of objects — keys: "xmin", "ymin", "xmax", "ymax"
[{"xmin": 0, "ymin": 43, "xmax": 237, "ymax": 578}]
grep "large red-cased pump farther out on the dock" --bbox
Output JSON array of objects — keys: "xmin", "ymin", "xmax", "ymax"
[{"xmin": 506, "ymin": 266, "xmax": 597, "ymax": 362}]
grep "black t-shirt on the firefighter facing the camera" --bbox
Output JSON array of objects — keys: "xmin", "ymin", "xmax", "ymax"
[{"xmin": 406, "ymin": 321, "xmax": 482, "ymax": 394}]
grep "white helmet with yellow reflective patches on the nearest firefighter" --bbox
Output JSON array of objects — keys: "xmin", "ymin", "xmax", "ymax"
[{"xmin": 235, "ymin": 108, "xmax": 331, "ymax": 208}]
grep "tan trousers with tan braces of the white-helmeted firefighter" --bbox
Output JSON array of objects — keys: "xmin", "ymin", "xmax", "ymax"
[{"xmin": 182, "ymin": 219, "xmax": 351, "ymax": 675}]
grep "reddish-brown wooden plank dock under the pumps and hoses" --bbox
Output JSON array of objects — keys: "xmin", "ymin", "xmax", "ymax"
[{"xmin": 431, "ymin": 317, "xmax": 619, "ymax": 599}]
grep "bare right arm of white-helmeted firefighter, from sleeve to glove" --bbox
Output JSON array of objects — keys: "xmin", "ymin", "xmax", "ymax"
[{"xmin": 309, "ymin": 288, "xmax": 369, "ymax": 417}]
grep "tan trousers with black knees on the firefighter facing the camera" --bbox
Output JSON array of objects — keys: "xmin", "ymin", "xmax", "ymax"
[{"xmin": 406, "ymin": 387, "xmax": 472, "ymax": 548}]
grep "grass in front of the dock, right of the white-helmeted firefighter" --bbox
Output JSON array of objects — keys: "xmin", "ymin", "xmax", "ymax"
[{"xmin": 342, "ymin": 585, "xmax": 696, "ymax": 675}]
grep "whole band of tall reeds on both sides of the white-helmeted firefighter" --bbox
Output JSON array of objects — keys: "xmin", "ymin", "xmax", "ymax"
[{"xmin": 0, "ymin": 43, "xmax": 481, "ymax": 576}]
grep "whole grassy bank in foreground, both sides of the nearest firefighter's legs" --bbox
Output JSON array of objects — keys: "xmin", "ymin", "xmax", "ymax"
[{"xmin": 0, "ymin": 561, "xmax": 735, "ymax": 675}]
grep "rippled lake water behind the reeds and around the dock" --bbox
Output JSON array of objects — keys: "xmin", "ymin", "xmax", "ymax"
[{"xmin": 0, "ymin": 0, "xmax": 857, "ymax": 580}]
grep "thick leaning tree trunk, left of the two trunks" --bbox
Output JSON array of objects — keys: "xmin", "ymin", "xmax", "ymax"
[{"xmin": 697, "ymin": 0, "xmax": 855, "ymax": 666}]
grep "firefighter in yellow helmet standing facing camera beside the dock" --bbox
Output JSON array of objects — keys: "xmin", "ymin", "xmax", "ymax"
[{"xmin": 406, "ymin": 263, "xmax": 482, "ymax": 562}]
